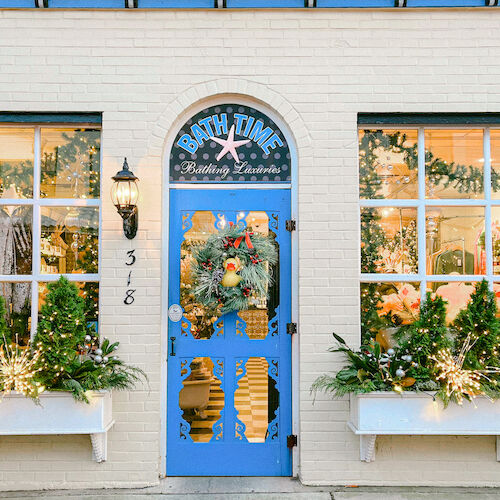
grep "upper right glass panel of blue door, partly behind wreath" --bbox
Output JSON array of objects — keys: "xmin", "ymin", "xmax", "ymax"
[{"xmin": 236, "ymin": 211, "xmax": 279, "ymax": 340}]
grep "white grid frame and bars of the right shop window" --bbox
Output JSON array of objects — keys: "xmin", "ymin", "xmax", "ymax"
[{"xmin": 358, "ymin": 123, "xmax": 500, "ymax": 301}]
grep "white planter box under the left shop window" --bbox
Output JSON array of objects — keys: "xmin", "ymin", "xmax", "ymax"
[{"xmin": 0, "ymin": 391, "xmax": 114, "ymax": 462}]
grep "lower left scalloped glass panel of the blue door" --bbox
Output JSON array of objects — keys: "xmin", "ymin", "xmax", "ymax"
[{"xmin": 179, "ymin": 357, "xmax": 224, "ymax": 443}]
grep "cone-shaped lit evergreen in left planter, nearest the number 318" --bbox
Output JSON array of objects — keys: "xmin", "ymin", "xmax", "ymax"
[{"xmin": 35, "ymin": 277, "xmax": 87, "ymax": 387}]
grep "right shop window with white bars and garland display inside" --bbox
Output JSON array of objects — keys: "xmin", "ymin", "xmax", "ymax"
[{"xmin": 359, "ymin": 126, "xmax": 500, "ymax": 343}]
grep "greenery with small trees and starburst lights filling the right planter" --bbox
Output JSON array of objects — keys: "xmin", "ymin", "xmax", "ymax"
[{"xmin": 312, "ymin": 280, "xmax": 500, "ymax": 405}]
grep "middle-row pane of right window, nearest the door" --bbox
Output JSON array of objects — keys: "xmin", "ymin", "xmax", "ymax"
[{"xmin": 361, "ymin": 207, "xmax": 418, "ymax": 274}]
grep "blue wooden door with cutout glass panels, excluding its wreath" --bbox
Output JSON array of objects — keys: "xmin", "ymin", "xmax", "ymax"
[{"xmin": 167, "ymin": 189, "xmax": 292, "ymax": 476}]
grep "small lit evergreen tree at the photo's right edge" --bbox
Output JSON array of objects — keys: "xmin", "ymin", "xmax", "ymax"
[{"xmin": 453, "ymin": 280, "xmax": 500, "ymax": 370}]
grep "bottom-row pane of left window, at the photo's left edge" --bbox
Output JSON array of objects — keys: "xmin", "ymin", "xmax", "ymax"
[{"xmin": 0, "ymin": 282, "xmax": 31, "ymax": 346}]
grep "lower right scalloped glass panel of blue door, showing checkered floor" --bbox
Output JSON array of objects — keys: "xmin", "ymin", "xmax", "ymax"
[{"xmin": 234, "ymin": 357, "xmax": 279, "ymax": 443}]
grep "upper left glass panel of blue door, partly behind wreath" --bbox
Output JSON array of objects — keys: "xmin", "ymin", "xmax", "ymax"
[{"xmin": 180, "ymin": 211, "xmax": 225, "ymax": 339}]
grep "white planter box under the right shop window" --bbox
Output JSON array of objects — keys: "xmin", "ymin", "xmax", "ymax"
[{"xmin": 348, "ymin": 392, "xmax": 500, "ymax": 462}]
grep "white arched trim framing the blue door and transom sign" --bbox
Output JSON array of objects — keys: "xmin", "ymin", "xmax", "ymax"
[{"xmin": 160, "ymin": 92, "xmax": 300, "ymax": 477}]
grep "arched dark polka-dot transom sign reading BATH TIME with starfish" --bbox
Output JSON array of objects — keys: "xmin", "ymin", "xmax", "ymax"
[{"xmin": 170, "ymin": 104, "xmax": 291, "ymax": 183}]
